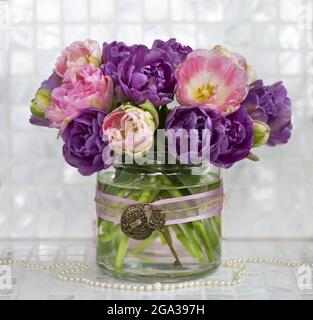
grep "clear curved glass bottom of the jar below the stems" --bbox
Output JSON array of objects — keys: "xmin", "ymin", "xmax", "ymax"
[{"xmin": 97, "ymin": 259, "xmax": 220, "ymax": 283}]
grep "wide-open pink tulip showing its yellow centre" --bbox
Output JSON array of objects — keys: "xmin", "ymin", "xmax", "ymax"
[{"xmin": 176, "ymin": 48, "xmax": 249, "ymax": 115}]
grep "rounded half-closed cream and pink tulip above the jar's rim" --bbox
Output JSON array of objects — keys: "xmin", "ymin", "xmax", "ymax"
[{"xmin": 102, "ymin": 104, "xmax": 156, "ymax": 156}]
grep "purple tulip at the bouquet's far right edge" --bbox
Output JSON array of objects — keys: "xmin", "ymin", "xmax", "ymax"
[{"xmin": 241, "ymin": 80, "xmax": 292, "ymax": 146}]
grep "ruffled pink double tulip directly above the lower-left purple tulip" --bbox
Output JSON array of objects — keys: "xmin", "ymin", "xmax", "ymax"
[{"xmin": 45, "ymin": 64, "xmax": 113, "ymax": 129}]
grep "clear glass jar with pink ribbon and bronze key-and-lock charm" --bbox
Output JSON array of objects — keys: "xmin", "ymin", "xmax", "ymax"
[{"xmin": 96, "ymin": 164, "xmax": 223, "ymax": 281}]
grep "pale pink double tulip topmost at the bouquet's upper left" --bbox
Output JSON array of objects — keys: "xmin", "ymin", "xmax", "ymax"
[{"xmin": 55, "ymin": 39, "xmax": 101, "ymax": 79}]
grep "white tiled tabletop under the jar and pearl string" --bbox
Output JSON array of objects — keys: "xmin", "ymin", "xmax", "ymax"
[{"xmin": 0, "ymin": 240, "xmax": 313, "ymax": 300}]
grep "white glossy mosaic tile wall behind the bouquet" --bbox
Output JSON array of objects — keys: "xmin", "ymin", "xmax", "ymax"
[{"xmin": 0, "ymin": 0, "xmax": 313, "ymax": 238}]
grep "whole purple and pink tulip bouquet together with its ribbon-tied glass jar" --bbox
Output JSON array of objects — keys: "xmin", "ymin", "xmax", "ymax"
[{"xmin": 30, "ymin": 39, "xmax": 292, "ymax": 279}]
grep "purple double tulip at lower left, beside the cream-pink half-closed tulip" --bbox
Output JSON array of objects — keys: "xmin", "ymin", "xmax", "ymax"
[{"xmin": 62, "ymin": 108, "xmax": 108, "ymax": 176}]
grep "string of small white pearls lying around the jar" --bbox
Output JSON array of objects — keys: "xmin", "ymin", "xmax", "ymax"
[{"xmin": 0, "ymin": 258, "xmax": 313, "ymax": 291}]
